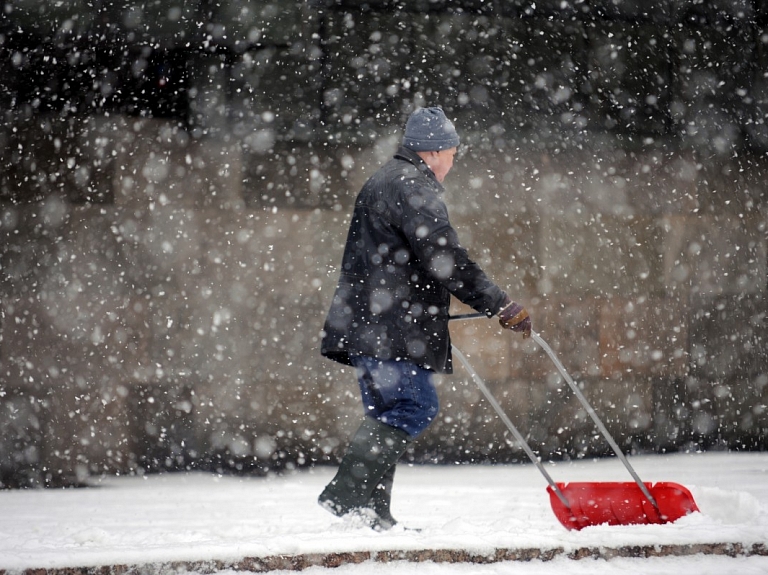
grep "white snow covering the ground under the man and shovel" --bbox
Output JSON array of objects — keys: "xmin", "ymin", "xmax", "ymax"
[{"xmin": 0, "ymin": 453, "xmax": 768, "ymax": 575}]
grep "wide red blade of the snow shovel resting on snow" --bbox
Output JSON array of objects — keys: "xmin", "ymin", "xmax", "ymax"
[{"xmin": 547, "ymin": 482, "xmax": 699, "ymax": 530}]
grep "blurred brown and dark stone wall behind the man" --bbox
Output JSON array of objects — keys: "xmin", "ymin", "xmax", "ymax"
[{"xmin": 0, "ymin": 0, "xmax": 768, "ymax": 486}]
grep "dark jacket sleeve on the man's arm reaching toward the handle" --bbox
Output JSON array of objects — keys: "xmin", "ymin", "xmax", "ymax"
[{"xmin": 401, "ymin": 181, "xmax": 507, "ymax": 317}]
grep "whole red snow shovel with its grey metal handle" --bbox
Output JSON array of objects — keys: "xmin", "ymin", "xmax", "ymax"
[{"xmin": 451, "ymin": 314, "xmax": 699, "ymax": 530}]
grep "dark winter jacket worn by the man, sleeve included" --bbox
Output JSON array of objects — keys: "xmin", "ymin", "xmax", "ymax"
[{"xmin": 321, "ymin": 147, "xmax": 506, "ymax": 373}]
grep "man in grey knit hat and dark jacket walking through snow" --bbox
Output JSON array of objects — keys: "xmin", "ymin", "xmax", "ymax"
[{"xmin": 318, "ymin": 107, "xmax": 531, "ymax": 530}]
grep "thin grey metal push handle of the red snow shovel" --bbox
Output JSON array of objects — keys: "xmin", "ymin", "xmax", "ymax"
[{"xmin": 450, "ymin": 313, "xmax": 661, "ymax": 514}]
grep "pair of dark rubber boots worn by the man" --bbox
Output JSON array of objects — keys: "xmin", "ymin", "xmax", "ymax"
[{"xmin": 318, "ymin": 417, "xmax": 411, "ymax": 529}]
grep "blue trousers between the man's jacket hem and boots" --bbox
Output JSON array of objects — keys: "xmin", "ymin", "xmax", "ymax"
[{"xmin": 350, "ymin": 355, "xmax": 439, "ymax": 437}]
